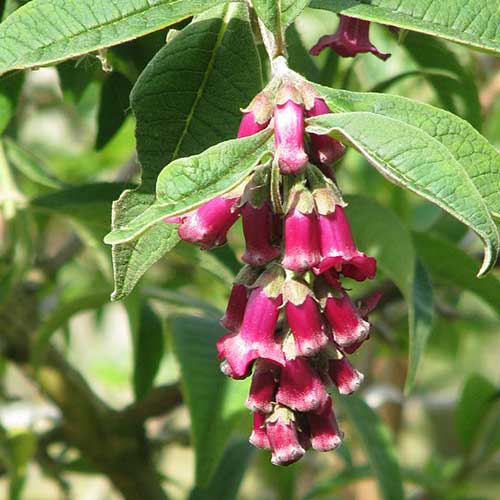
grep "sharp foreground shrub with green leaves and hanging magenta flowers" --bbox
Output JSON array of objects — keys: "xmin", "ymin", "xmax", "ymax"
[{"xmin": 0, "ymin": 0, "xmax": 500, "ymax": 498}]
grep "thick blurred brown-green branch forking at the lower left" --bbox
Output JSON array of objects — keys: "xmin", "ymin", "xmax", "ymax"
[{"xmin": 0, "ymin": 286, "xmax": 180, "ymax": 500}]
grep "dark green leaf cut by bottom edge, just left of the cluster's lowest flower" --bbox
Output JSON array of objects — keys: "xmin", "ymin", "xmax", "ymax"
[{"xmin": 189, "ymin": 440, "xmax": 255, "ymax": 500}]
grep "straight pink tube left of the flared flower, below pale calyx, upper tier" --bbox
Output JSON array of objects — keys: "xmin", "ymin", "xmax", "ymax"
[{"xmin": 283, "ymin": 208, "xmax": 321, "ymax": 273}]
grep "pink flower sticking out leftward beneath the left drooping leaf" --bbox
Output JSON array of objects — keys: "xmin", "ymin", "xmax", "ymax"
[{"xmin": 176, "ymin": 196, "xmax": 240, "ymax": 250}]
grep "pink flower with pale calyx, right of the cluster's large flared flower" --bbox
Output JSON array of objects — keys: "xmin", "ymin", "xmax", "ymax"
[{"xmin": 285, "ymin": 280, "xmax": 328, "ymax": 356}]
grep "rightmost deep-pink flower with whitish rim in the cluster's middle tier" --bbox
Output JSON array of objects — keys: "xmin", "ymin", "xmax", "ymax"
[{"xmin": 325, "ymin": 289, "xmax": 370, "ymax": 348}]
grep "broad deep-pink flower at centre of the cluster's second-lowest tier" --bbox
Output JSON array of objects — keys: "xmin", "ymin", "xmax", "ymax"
[{"xmin": 276, "ymin": 358, "xmax": 328, "ymax": 412}]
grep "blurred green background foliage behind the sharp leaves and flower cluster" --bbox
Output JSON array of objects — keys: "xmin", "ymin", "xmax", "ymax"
[{"xmin": 0, "ymin": 1, "xmax": 500, "ymax": 500}]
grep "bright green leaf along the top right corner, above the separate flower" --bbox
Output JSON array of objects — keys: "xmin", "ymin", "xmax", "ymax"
[{"xmin": 311, "ymin": 0, "xmax": 500, "ymax": 54}]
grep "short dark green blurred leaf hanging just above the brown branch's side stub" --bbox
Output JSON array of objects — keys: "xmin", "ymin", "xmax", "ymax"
[{"xmin": 126, "ymin": 296, "xmax": 165, "ymax": 400}]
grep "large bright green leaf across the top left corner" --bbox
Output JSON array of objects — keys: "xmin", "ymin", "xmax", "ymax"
[{"xmin": 0, "ymin": 0, "xmax": 232, "ymax": 74}]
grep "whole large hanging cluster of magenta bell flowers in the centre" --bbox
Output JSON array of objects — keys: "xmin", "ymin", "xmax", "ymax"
[{"xmin": 169, "ymin": 78, "xmax": 376, "ymax": 465}]
